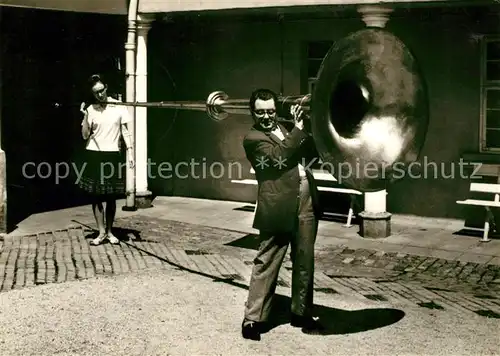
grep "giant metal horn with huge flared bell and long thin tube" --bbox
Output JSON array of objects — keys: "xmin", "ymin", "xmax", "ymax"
[{"xmin": 56, "ymin": 28, "xmax": 429, "ymax": 192}]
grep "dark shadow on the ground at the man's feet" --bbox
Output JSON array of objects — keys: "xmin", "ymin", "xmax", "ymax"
[{"xmin": 266, "ymin": 295, "xmax": 405, "ymax": 335}]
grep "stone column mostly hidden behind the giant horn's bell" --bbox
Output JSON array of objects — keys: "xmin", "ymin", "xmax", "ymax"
[{"xmin": 358, "ymin": 5, "xmax": 393, "ymax": 238}]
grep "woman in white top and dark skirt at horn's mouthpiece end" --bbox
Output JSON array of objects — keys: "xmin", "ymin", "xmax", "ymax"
[{"xmin": 78, "ymin": 74, "xmax": 134, "ymax": 245}]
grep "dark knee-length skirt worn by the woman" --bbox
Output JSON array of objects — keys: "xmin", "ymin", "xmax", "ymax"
[{"xmin": 77, "ymin": 150, "xmax": 126, "ymax": 199}]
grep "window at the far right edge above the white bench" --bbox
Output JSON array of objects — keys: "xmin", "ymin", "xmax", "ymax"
[{"xmin": 480, "ymin": 37, "xmax": 500, "ymax": 153}]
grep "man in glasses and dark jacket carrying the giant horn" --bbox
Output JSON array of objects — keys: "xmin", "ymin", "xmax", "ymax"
[{"xmin": 242, "ymin": 89, "xmax": 322, "ymax": 340}]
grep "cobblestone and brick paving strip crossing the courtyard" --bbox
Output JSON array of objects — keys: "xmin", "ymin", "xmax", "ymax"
[{"xmin": 0, "ymin": 216, "xmax": 500, "ymax": 318}]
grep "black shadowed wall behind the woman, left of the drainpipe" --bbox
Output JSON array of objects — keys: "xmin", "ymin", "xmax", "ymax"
[{"xmin": 1, "ymin": 7, "xmax": 127, "ymax": 231}]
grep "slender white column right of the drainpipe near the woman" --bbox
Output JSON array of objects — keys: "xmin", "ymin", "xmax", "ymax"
[{"xmin": 135, "ymin": 14, "xmax": 153, "ymax": 209}]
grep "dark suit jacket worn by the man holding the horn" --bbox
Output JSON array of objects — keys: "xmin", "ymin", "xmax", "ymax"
[{"xmin": 243, "ymin": 125, "xmax": 322, "ymax": 232}]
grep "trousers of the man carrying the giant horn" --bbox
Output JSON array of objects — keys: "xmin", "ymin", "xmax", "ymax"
[{"xmin": 245, "ymin": 177, "xmax": 318, "ymax": 322}]
